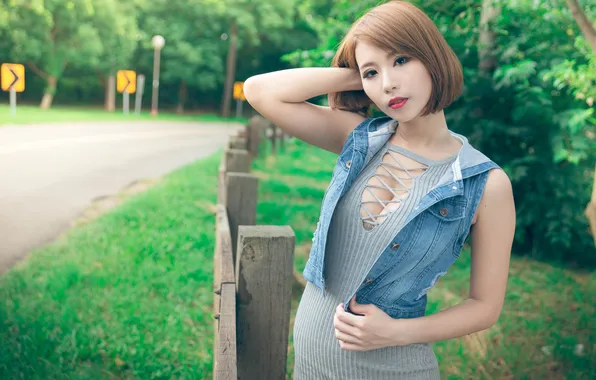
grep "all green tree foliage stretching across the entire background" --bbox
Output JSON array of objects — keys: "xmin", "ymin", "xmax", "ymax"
[{"xmin": 0, "ymin": 0, "xmax": 596, "ymax": 264}]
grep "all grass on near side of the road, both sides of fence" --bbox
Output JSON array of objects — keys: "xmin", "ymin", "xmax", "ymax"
[{"xmin": 0, "ymin": 136, "xmax": 596, "ymax": 379}]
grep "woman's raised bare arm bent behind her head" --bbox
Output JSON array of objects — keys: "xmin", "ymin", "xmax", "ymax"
[{"xmin": 244, "ymin": 67, "xmax": 364, "ymax": 154}]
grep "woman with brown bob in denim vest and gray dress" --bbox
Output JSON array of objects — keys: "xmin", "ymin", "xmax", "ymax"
[{"xmin": 244, "ymin": 1, "xmax": 515, "ymax": 380}]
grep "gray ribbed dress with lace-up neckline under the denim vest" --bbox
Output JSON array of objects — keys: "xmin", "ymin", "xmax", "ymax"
[{"xmin": 294, "ymin": 142, "xmax": 456, "ymax": 380}]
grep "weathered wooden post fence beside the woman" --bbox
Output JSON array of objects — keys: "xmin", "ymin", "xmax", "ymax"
[{"xmin": 213, "ymin": 116, "xmax": 296, "ymax": 380}]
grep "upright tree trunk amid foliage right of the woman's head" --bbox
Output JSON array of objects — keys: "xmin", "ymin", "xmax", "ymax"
[{"xmin": 478, "ymin": 0, "xmax": 501, "ymax": 77}]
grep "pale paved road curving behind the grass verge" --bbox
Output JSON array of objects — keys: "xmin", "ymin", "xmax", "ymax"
[{"xmin": 0, "ymin": 122, "xmax": 241, "ymax": 273}]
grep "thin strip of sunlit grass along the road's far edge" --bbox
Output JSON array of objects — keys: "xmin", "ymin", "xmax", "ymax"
[{"xmin": 0, "ymin": 104, "xmax": 246, "ymax": 127}]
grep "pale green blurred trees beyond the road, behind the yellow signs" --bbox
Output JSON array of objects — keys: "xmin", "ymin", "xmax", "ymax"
[{"xmin": 0, "ymin": 0, "xmax": 317, "ymax": 107}]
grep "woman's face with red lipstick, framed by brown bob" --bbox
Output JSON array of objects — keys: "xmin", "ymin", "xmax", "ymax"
[{"xmin": 356, "ymin": 41, "xmax": 432, "ymax": 123}]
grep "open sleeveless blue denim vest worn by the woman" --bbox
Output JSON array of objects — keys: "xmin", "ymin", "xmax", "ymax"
[{"xmin": 303, "ymin": 117, "xmax": 498, "ymax": 318}]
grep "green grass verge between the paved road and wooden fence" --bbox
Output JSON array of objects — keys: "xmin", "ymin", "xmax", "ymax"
[{"xmin": 0, "ymin": 151, "xmax": 224, "ymax": 379}]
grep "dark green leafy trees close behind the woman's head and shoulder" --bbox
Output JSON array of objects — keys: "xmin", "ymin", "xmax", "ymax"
[{"xmin": 284, "ymin": 0, "xmax": 596, "ymax": 265}]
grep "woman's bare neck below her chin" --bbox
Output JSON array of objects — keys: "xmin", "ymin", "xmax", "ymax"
[{"xmin": 394, "ymin": 110, "xmax": 453, "ymax": 148}]
